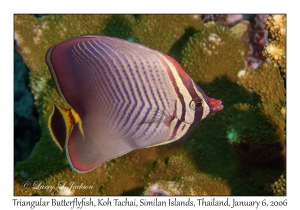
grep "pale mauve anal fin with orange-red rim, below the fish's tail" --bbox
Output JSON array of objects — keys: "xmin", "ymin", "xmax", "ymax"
[{"xmin": 66, "ymin": 123, "xmax": 133, "ymax": 173}]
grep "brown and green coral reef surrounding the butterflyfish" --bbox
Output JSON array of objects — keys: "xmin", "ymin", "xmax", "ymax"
[{"xmin": 14, "ymin": 15, "xmax": 285, "ymax": 195}]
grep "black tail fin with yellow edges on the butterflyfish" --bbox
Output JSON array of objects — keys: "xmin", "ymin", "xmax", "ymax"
[{"xmin": 48, "ymin": 104, "xmax": 76, "ymax": 151}]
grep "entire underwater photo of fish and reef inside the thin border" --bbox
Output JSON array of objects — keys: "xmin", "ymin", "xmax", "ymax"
[{"xmin": 14, "ymin": 14, "xmax": 286, "ymax": 196}]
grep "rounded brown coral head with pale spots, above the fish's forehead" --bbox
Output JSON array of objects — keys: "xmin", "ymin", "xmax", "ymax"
[{"xmin": 182, "ymin": 22, "xmax": 245, "ymax": 84}]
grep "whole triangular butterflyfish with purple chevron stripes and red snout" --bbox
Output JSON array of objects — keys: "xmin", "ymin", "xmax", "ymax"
[{"xmin": 46, "ymin": 35, "xmax": 223, "ymax": 173}]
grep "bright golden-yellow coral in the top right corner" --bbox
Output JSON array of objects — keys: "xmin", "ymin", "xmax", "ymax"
[{"xmin": 263, "ymin": 14, "xmax": 286, "ymax": 79}]
